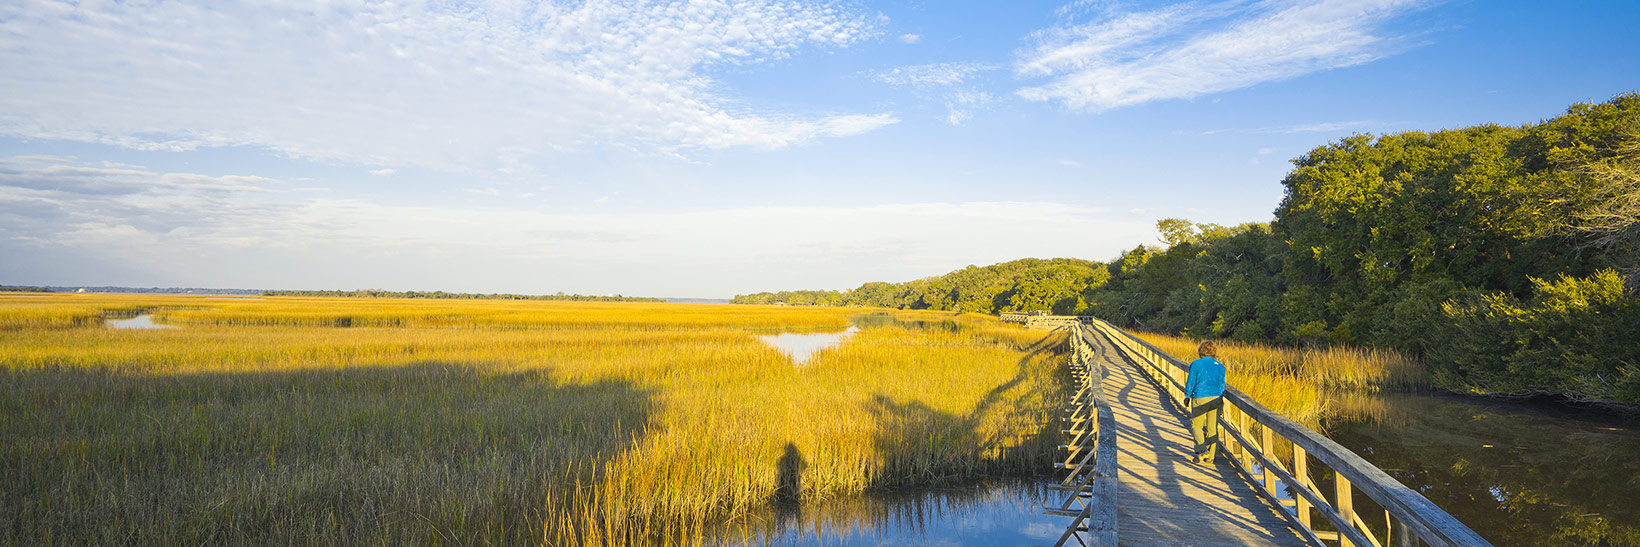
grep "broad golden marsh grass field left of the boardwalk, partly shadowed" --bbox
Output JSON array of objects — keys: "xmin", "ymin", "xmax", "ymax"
[{"xmin": 0, "ymin": 295, "xmax": 1064, "ymax": 544}]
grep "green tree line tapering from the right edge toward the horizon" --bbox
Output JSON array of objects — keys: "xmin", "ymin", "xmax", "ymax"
[{"xmin": 735, "ymin": 93, "xmax": 1640, "ymax": 405}]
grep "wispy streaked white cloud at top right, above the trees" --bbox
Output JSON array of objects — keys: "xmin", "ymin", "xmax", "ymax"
[{"xmin": 1015, "ymin": 0, "xmax": 1428, "ymax": 111}]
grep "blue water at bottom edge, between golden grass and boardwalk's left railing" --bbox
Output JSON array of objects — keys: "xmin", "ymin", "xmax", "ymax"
[{"xmin": 710, "ymin": 480, "xmax": 1069, "ymax": 547}]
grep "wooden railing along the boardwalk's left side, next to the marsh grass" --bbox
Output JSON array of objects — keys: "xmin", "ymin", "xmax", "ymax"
[{"xmin": 1043, "ymin": 326, "xmax": 1117, "ymax": 547}]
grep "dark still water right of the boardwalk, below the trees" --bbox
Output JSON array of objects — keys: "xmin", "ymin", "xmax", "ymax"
[{"xmin": 1325, "ymin": 395, "xmax": 1640, "ymax": 545}]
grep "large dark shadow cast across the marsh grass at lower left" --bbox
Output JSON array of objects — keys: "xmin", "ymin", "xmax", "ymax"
[{"xmin": 0, "ymin": 362, "xmax": 654, "ymax": 544}]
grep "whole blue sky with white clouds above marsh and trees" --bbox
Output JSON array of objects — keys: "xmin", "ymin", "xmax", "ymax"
[{"xmin": 0, "ymin": 0, "xmax": 1640, "ymax": 298}]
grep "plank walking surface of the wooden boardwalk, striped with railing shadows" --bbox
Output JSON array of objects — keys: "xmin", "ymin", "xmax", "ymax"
[{"xmin": 1091, "ymin": 327, "xmax": 1310, "ymax": 545}]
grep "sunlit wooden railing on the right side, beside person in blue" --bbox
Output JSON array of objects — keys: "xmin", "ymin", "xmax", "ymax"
[{"xmin": 1091, "ymin": 319, "xmax": 1491, "ymax": 547}]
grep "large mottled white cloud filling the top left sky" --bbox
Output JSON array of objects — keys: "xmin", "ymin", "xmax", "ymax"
[{"xmin": 0, "ymin": 0, "xmax": 897, "ymax": 172}]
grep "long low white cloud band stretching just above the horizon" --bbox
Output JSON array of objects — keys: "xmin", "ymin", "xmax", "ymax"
[{"xmin": 0, "ymin": 159, "xmax": 1151, "ymax": 296}]
